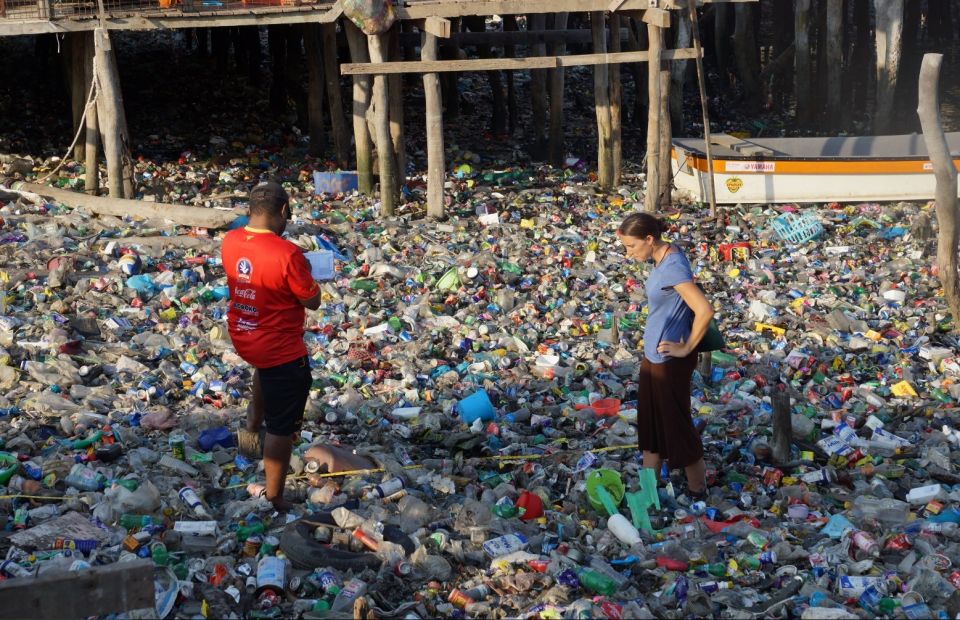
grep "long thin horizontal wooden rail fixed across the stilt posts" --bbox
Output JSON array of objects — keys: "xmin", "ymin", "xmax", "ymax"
[{"xmin": 340, "ymin": 47, "xmax": 696, "ymax": 75}]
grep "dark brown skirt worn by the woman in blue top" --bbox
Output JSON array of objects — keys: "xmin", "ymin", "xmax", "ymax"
[{"xmin": 637, "ymin": 353, "xmax": 703, "ymax": 469}]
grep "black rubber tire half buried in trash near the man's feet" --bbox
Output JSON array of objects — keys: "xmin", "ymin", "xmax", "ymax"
[{"xmin": 280, "ymin": 512, "xmax": 416, "ymax": 572}]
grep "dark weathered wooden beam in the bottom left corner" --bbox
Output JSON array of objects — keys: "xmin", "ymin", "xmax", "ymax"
[{"xmin": 0, "ymin": 560, "xmax": 155, "ymax": 620}]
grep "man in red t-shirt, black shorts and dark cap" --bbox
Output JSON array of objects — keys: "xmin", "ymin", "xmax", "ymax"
[{"xmin": 221, "ymin": 181, "xmax": 320, "ymax": 510}]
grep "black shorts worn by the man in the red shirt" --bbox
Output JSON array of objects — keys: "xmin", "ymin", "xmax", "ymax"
[{"xmin": 258, "ymin": 355, "xmax": 313, "ymax": 435}]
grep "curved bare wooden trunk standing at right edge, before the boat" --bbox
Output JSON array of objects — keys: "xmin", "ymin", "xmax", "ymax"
[{"xmin": 917, "ymin": 54, "xmax": 960, "ymax": 333}]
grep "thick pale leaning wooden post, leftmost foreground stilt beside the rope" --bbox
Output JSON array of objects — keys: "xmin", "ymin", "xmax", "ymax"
[{"xmin": 94, "ymin": 28, "xmax": 133, "ymax": 198}]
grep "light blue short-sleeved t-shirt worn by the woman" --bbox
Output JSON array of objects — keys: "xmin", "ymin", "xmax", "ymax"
[{"xmin": 643, "ymin": 245, "xmax": 693, "ymax": 364}]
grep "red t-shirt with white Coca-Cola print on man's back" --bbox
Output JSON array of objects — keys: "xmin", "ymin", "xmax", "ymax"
[{"xmin": 220, "ymin": 228, "xmax": 320, "ymax": 368}]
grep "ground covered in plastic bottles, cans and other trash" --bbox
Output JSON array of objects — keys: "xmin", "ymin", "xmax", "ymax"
[{"xmin": 0, "ymin": 30, "xmax": 960, "ymax": 618}]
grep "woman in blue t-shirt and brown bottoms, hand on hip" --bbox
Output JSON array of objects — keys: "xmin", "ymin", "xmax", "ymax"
[{"xmin": 617, "ymin": 213, "xmax": 713, "ymax": 499}]
